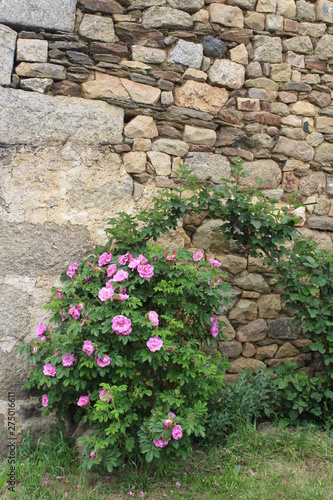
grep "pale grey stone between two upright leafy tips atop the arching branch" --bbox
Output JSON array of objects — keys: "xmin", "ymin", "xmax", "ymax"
[{"xmin": 186, "ymin": 152, "xmax": 231, "ymax": 184}]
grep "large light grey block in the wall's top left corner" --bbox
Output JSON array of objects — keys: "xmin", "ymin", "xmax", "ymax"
[{"xmin": 0, "ymin": 0, "xmax": 76, "ymax": 33}]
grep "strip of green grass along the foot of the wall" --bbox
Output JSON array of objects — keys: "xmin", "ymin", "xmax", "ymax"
[{"xmin": 0, "ymin": 426, "xmax": 333, "ymax": 500}]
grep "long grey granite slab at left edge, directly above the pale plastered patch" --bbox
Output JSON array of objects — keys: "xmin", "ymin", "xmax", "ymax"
[{"xmin": 0, "ymin": 89, "xmax": 124, "ymax": 145}]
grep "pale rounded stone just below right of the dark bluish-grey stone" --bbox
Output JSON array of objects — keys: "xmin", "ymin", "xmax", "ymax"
[{"xmin": 208, "ymin": 59, "xmax": 245, "ymax": 89}]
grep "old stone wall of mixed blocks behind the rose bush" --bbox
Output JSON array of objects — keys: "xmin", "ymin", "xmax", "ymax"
[{"xmin": 0, "ymin": 0, "xmax": 333, "ymax": 432}]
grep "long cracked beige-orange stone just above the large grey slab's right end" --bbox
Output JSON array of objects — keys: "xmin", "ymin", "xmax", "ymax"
[{"xmin": 82, "ymin": 72, "xmax": 161, "ymax": 106}]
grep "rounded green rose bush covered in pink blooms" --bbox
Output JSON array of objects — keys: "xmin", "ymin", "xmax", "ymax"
[{"xmin": 20, "ymin": 232, "xmax": 230, "ymax": 471}]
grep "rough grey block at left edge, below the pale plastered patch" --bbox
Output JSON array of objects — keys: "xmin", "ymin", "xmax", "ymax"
[{"xmin": 0, "ymin": 221, "xmax": 92, "ymax": 277}]
